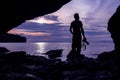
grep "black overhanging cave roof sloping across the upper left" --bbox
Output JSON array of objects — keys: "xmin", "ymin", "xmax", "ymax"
[{"xmin": 0, "ymin": 0, "xmax": 70, "ymax": 33}]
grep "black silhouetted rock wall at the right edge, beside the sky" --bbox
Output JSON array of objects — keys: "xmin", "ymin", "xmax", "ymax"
[{"xmin": 108, "ymin": 5, "xmax": 120, "ymax": 52}]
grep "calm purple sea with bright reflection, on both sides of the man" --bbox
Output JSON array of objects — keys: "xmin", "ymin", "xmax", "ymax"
[{"xmin": 0, "ymin": 42, "xmax": 113, "ymax": 60}]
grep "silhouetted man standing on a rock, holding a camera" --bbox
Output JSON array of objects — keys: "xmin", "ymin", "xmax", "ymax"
[{"xmin": 70, "ymin": 13, "xmax": 87, "ymax": 53}]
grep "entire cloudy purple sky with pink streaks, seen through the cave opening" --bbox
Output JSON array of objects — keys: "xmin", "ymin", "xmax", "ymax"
[{"xmin": 8, "ymin": 0, "xmax": 120, "ymax": 42}]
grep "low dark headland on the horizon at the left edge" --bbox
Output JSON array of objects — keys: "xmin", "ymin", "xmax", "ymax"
[{"xmin": 0, "ymin": 33, "xmax": 26, "ymax": 42}]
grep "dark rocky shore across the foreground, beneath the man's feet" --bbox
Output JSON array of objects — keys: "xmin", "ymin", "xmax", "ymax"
[{"xmin": 0, "ymin": 47, "xmax": 120, "ymax": 80}]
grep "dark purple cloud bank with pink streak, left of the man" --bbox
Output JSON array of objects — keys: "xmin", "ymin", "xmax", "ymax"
[{"xmin": 9, "ymin": 22, "xmax": 71, "ymax": 42}]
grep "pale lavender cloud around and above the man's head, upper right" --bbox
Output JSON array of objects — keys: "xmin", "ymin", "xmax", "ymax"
[{"xmin": 49, "ymin": 0, "xmax": 120, "ymax": 25}]
